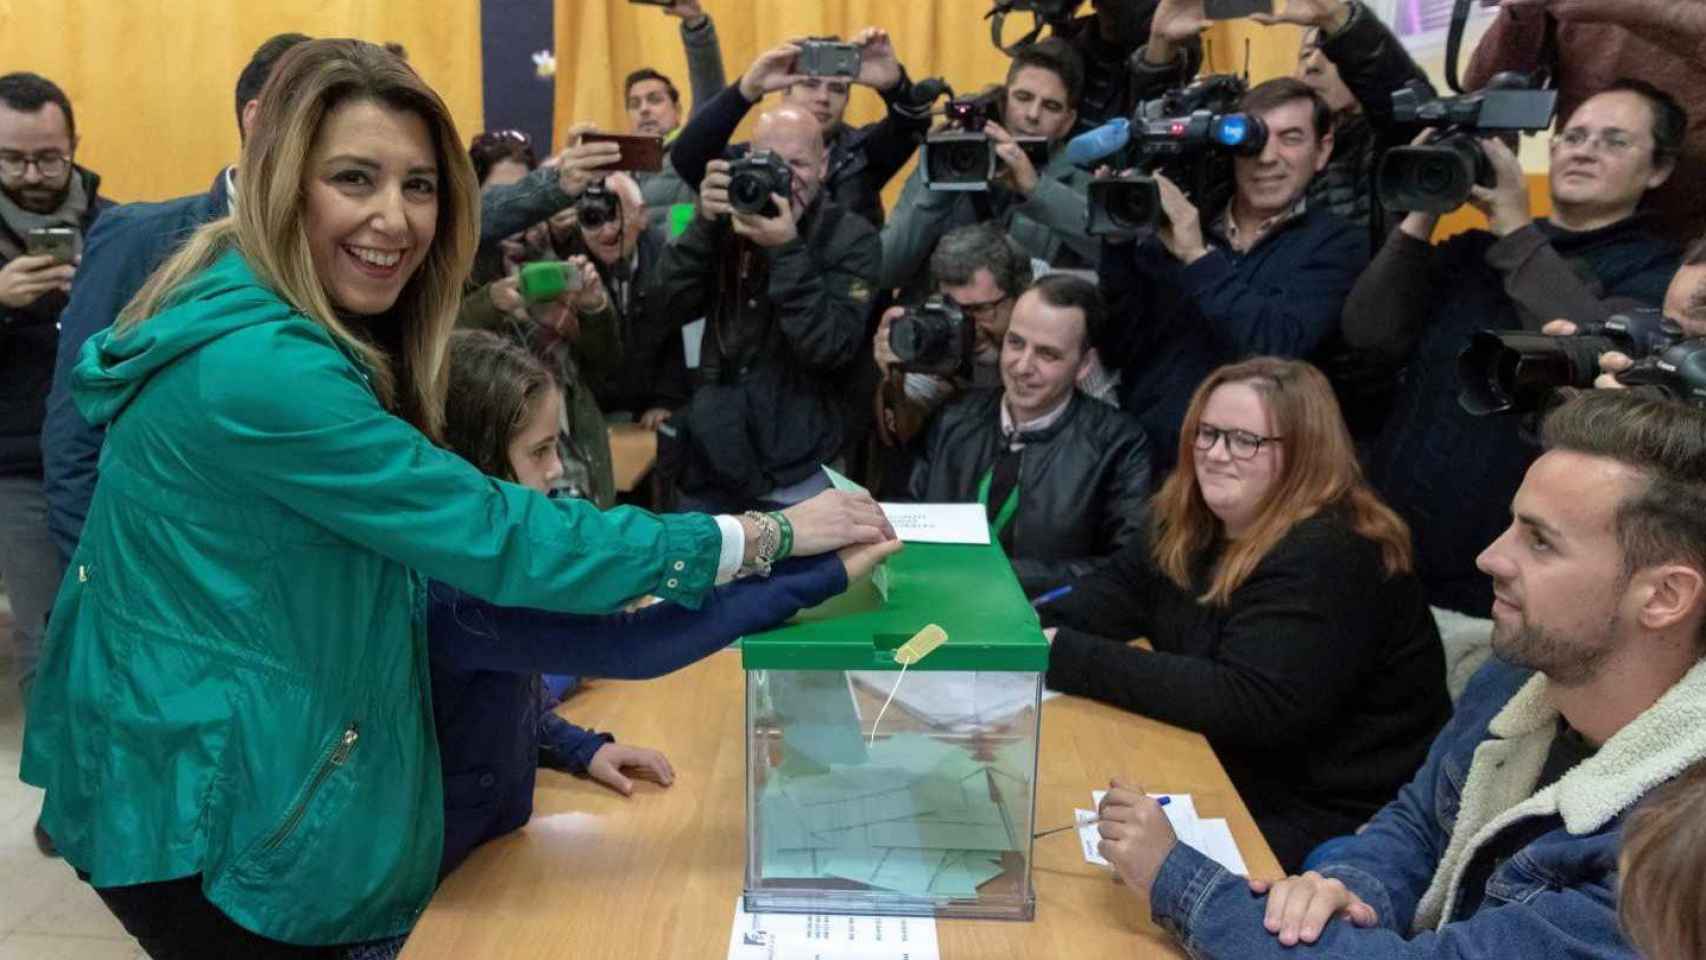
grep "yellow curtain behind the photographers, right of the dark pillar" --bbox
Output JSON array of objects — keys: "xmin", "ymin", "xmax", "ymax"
[{"xmin": 556, "ymin": 0, "xmax": 1298, "ymax": 208}]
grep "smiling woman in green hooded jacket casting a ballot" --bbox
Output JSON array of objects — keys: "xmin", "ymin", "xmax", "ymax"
[{"xmin": 22, "ymin": 41, "xmax": 892, "ymax": 960}]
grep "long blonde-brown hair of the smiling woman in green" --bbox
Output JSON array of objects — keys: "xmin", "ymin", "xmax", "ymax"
[{"xmin": 114, "ymin": 39, "xmax": 479, "ymax": 442}]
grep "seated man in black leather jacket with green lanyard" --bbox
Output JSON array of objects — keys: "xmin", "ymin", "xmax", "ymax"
[{"xmin": 908, "ymin": 275, "xmax": 1150, "ymax": 593}]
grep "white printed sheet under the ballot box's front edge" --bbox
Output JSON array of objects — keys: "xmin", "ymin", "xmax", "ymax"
[{"xmin": 728, "ymin": 897, "xmax": 942, "ymax": 960}]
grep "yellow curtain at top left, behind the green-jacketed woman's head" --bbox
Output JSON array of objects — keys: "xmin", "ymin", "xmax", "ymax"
[{"xmin": 0, "ymin": 0, "xmax": 481, "ymax": 201}]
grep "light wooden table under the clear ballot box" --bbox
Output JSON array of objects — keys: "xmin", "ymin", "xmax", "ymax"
[{"xmin": 403, "ymin": 650, "xmax": 1280, "ymax": 960}]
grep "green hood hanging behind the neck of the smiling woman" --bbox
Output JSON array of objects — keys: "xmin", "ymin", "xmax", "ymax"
[{"xmin": 72, "ymin": 251, "xmax": 297, "ymax": 426}]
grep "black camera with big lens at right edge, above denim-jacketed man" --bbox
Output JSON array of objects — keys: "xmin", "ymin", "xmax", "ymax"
[{"xmin": 1457, "ymin": 309, "xmax": 1706, "ymax": 416}]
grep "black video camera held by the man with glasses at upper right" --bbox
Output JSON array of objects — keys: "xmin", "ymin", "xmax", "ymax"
[{"xmin": 1375, "ymin": 73, "xmax": 1558, "ymax": 213}]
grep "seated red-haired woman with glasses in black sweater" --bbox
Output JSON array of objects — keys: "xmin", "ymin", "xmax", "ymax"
[{"xmin": 1042, "ymin": 358, "xmax": 1452, "ymax": 873}]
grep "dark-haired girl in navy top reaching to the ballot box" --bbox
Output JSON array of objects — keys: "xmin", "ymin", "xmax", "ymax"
[{"xmin": 428, "ymin": 331, "xmax": 899, "ymax": 875}]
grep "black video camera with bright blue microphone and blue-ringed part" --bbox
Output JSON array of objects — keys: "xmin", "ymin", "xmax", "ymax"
[{"xmin": 1066, "ymin": 73, "xmax": 1268, "ymax": 239}]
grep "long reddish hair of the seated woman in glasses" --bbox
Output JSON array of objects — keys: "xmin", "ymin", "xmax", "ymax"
[{"xmin": 1150, "ymin": 356, "xmax": 1411, "ymax": 607}]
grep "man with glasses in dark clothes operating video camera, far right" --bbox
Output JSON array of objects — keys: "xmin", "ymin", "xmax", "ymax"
[{"xmin": 1343, "ymin": 80, "xmax": 1687, "ymax": 617}]
